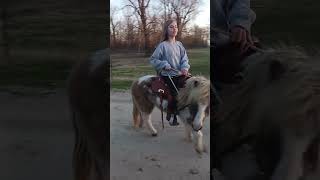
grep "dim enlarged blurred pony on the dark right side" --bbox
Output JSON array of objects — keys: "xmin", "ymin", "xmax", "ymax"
[{"xmin": 213, "ymin": 48, "xmax": 320, "ymax": 180}]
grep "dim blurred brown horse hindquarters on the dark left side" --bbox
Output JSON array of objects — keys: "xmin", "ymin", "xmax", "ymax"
[{"xmin": 68, "ymin": 49, "xmax": 110, "ymax": 180}]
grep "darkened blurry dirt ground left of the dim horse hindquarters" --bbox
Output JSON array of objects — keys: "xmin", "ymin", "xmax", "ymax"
[{"xmin": 0, "ymin": 90, "xmax": 73, "ymax": 180}]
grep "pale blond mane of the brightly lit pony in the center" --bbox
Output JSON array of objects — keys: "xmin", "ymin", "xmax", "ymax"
[{"xmin": 177, "ymin": 76, "xmax": 210, "ymax": 108}]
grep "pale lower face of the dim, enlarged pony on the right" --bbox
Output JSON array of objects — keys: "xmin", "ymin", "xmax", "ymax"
[{"xmin": 272, "ymin": 133, "xmax": 311, "ymax": 180}]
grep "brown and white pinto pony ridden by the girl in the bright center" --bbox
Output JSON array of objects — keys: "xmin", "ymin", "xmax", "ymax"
[{"xmin": 131, "ymin": 75, "xmax": 210, "ymax": 153}]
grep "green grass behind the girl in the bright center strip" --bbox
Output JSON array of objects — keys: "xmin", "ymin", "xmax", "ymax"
[{"xmin": 111, "ymin": 48, "xmax": 210, "ymax": 89}]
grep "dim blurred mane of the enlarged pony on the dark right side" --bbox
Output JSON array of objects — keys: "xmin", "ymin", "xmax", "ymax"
[{"xmin": 217, "ymin": 46, "xmax": 320, "ymax": 125}]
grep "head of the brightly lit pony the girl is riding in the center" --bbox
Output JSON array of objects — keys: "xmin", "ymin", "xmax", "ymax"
[{"xmin": 177, "ymin": 76, "xmax": 210, "ymax": 131}]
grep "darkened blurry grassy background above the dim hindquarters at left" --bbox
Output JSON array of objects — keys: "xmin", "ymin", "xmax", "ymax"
[{"xmin": 0, "ymin": 0, "xmax": 108, "ymax": 88}]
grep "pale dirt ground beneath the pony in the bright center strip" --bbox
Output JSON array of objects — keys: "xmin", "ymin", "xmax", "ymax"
[{"xmin": 110, "ymin": 92, "xmax": 210, "ymax": 180}]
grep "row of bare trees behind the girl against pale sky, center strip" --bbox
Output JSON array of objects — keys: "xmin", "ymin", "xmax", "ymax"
[{"xmin": 110, "ymin": 0, "xmax": 210, "ymax": 53}]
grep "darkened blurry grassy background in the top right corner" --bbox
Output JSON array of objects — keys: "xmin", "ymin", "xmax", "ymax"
[{"xmin": 251, "ymin": 0, "xmax": 320, "ymax": 47}]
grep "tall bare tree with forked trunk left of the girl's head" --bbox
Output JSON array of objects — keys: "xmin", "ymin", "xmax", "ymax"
[{"xmin": 127, "ymin": 0, "xmax": 150, "ymax": 54}]
